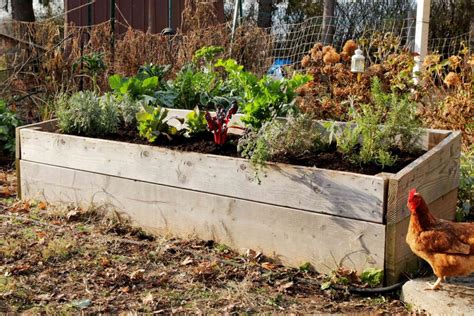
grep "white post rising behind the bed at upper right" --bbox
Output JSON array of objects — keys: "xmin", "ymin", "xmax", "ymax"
[{"xmin": 413, "ymin": 0, "xmax": 431, "ymax": 83}]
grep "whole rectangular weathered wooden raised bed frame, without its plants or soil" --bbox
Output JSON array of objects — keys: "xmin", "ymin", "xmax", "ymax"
[{"xmin": 17, "ymin": 110, "xmax": 461, "ymax": 283}]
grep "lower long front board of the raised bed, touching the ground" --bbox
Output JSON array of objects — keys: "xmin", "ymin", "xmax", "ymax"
[{"xmin": 21, "ymin": 161, "xmax": 385, "ymax": 272}]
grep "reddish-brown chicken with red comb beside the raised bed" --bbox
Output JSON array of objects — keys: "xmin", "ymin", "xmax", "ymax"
[{"xmin": 406, "ymin": 189, "xmax": 474, "ymax": 290}]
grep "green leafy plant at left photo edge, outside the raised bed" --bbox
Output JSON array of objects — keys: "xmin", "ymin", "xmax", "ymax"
[{"xmin": 0, "ymin": 99, "xmax": 21, "ymax": 156}]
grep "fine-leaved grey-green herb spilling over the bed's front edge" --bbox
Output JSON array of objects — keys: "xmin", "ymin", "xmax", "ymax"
[{"xmin": 238, "ymin": 114, "xmax": 328, "ymax": 167}]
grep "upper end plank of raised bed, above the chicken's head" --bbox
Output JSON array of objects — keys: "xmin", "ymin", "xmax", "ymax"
[{"xmin": 387, "ymin": 131, "xmax": 461, "ymax": 224}]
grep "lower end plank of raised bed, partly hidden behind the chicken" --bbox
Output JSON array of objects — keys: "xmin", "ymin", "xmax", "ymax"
[{"xmin": 385, "ymin": 188, "xmax": 458, "ymax": 284}]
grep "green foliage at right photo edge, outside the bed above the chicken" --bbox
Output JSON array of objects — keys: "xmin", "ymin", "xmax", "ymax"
[{"xmin": 456, "ymin": 146, "xmax": 474, "ymax": 221}]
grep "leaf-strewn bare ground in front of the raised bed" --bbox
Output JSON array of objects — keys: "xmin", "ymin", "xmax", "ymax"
[{"xmin": 0, "ymin": 172, "xmax": 408, "ymax": 314}]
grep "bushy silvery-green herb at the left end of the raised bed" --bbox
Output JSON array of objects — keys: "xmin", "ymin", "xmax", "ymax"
[{"xmin": 56, "ymin": 91, "xmax": 120, "ymax": 137}]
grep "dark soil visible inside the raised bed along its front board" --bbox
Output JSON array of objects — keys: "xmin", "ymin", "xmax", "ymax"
[{"xmin": 102, "ymin": 130, "xmax": 423, "ymax": 175}]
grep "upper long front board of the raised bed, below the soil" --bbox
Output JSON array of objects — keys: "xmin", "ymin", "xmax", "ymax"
[{"xmin": 20, "ymin": 129, "xmax": 385, "ymax": 223}]
